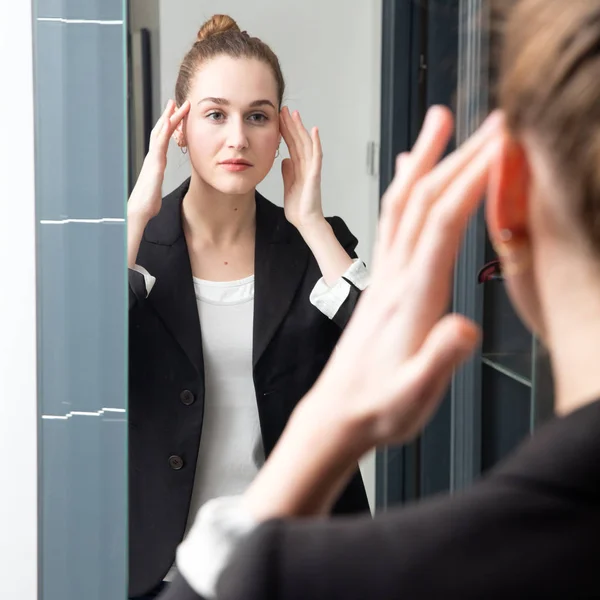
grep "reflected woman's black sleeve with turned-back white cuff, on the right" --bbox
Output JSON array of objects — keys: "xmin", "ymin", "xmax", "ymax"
[{"xmin": 310, "ymin": 217, "xmax": 369, "ymax": 329}]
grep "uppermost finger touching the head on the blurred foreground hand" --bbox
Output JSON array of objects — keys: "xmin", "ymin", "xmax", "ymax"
[{"xmin": 395, "ymin": 113, "xmax": 502, "ymax": 257}]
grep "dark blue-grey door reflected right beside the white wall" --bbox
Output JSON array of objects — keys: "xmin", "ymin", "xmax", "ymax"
[{"xmin": 377, "ymin": 0, "xmax": 458, "ymax": 509}]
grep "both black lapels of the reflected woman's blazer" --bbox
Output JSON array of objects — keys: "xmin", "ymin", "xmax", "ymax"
[{"xmin": 140, "ymin": 179, "xmax": 309, "ymax": 372}]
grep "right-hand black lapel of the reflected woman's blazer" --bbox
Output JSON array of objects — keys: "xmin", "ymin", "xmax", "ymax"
[{"xmin": 252, "ymin": 192, "xmax": 309, "ymax": 366}]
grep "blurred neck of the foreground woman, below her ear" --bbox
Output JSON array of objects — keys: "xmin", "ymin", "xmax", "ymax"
[{"xmin": 539, "ymin": 248, "xmax": 600, "ymax": 415}]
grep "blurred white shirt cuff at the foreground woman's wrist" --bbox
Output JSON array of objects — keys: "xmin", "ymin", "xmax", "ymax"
[{"xmin": 177, "ymin": 496, "xmax": 258, "ymax": 600}]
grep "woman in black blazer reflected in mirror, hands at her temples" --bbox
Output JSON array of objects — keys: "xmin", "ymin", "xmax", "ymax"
[{"xmin": 128, "ymin": 15, "xmax": 369, "ymax": 597}]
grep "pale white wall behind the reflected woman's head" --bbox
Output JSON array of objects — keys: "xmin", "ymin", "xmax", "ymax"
[{"xmin": 159, "ymin": 0, "xmax": 381, "ymax": 510}]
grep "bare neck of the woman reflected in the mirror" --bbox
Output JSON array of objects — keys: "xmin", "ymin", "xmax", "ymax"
[{"xmin": 182, "ymin": 174, "xmax": 256, "ymax": 246}]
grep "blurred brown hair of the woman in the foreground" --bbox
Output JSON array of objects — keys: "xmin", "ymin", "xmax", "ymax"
[{"xmin": 498, "ymin": 0, "xmax": 600, "ymax": 254}]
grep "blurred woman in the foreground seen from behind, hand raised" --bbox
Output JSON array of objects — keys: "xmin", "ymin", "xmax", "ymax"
[{"xmin": 159, "ymin": 0, "xmax": 600, "ymax": 600}]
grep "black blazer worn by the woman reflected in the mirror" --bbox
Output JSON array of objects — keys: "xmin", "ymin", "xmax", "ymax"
[{"xmin": 129, "ymin": 180, "xmax": 369, "ymax": 596}]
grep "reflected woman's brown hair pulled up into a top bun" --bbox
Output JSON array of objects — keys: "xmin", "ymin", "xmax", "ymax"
[{"xmin": 175, "ymin": 15, "xmax": 285, "ymax": 106}]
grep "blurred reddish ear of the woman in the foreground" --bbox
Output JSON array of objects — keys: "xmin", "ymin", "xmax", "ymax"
[{"xmin": 485, "ymin": 133, "xmax": 530, "ymax": 246}]
